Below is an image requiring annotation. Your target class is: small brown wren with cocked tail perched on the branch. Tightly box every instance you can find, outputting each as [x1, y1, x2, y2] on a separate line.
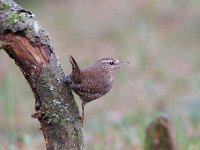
[64, 56, 129, 123]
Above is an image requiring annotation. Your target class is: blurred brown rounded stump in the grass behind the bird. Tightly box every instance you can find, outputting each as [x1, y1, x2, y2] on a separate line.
[145, 116, 177, 150]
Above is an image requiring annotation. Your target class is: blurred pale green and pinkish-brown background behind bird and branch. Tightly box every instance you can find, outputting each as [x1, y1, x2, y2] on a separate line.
[0, 0, 200, 150]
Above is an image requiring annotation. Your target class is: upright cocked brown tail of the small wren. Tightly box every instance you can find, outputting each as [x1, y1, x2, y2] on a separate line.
[69, 55, 82, 84]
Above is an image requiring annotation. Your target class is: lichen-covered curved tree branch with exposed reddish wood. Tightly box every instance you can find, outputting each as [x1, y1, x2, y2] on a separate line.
[0, 0, 83, 150]
